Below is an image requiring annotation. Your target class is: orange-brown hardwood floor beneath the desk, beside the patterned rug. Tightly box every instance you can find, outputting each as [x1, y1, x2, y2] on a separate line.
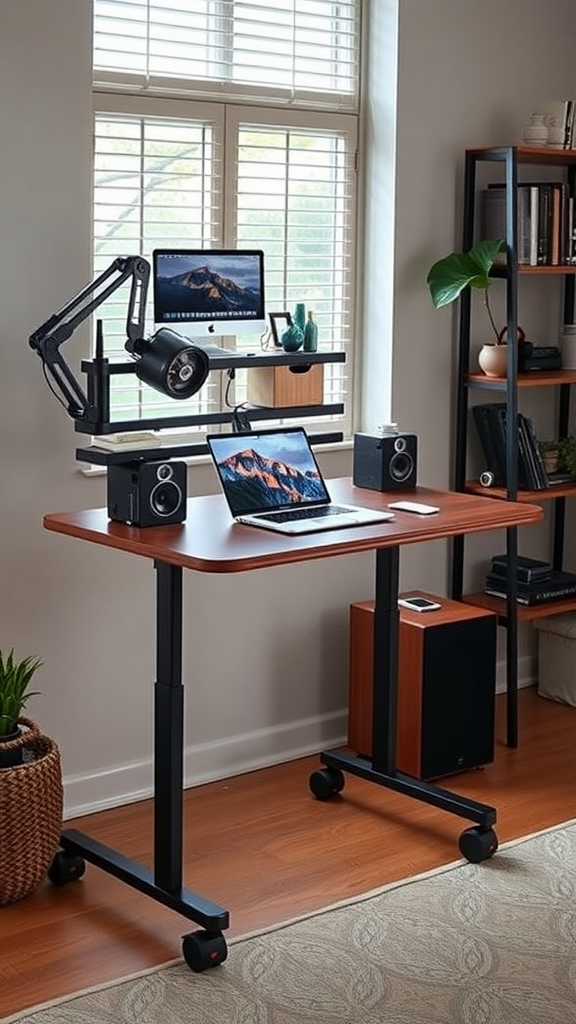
[0, 689, 576, 1019]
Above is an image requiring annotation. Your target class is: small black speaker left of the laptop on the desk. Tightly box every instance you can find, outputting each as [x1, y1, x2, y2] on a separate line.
[108, 462, 187, 526]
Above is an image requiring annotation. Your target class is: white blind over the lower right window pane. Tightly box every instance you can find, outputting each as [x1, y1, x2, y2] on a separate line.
[228, 111, 356, 415]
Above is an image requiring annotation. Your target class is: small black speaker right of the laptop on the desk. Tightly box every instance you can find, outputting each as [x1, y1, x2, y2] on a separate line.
[353, 433, 418, 490]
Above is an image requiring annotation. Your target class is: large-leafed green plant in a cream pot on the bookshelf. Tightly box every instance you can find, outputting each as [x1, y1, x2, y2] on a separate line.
[426, 239, 510, 377]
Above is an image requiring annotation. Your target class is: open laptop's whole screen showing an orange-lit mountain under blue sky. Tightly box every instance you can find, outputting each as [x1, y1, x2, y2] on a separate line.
[206, 427, 330, 516]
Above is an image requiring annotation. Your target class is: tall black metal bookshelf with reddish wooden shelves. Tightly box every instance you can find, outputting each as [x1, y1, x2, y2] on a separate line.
[451, 145, 576, 746]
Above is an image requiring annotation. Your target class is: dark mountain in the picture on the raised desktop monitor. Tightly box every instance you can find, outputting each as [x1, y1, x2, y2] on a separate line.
[158, 266, 259, 317]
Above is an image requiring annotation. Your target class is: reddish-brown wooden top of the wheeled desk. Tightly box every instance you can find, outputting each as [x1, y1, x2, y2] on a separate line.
[43, 477, 543, 572]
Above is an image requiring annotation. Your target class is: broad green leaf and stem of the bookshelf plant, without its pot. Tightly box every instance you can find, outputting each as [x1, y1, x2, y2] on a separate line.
[426, 239, 506, 345]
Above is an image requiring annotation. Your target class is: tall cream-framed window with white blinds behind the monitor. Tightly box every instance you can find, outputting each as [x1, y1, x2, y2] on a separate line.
[94, 0, 360, 434]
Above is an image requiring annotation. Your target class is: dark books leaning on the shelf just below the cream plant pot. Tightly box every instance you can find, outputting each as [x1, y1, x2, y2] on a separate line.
[472, 401, 550, 490]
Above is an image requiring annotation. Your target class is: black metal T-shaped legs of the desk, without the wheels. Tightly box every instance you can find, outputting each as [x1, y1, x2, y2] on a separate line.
[60, 547, 496, 950]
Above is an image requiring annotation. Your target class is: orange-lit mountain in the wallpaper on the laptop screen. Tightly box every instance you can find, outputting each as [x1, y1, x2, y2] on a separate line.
[218, 449, 326, 515]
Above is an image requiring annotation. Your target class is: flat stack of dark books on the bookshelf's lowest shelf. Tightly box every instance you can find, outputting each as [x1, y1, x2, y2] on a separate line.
[484, 555, 576, 605]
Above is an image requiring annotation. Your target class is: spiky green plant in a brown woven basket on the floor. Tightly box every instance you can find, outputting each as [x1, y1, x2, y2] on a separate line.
[0, 650, 63, 905]
